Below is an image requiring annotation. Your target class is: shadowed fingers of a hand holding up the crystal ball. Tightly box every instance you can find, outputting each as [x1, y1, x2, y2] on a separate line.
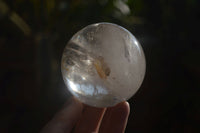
[41, 98, 130, 133]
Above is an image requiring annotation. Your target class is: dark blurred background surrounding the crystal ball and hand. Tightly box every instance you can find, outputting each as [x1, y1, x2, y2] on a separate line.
[0, 0, 200, 133]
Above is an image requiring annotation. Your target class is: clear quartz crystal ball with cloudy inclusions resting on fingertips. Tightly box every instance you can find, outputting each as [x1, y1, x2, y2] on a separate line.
[61, 23, 146, 107]
